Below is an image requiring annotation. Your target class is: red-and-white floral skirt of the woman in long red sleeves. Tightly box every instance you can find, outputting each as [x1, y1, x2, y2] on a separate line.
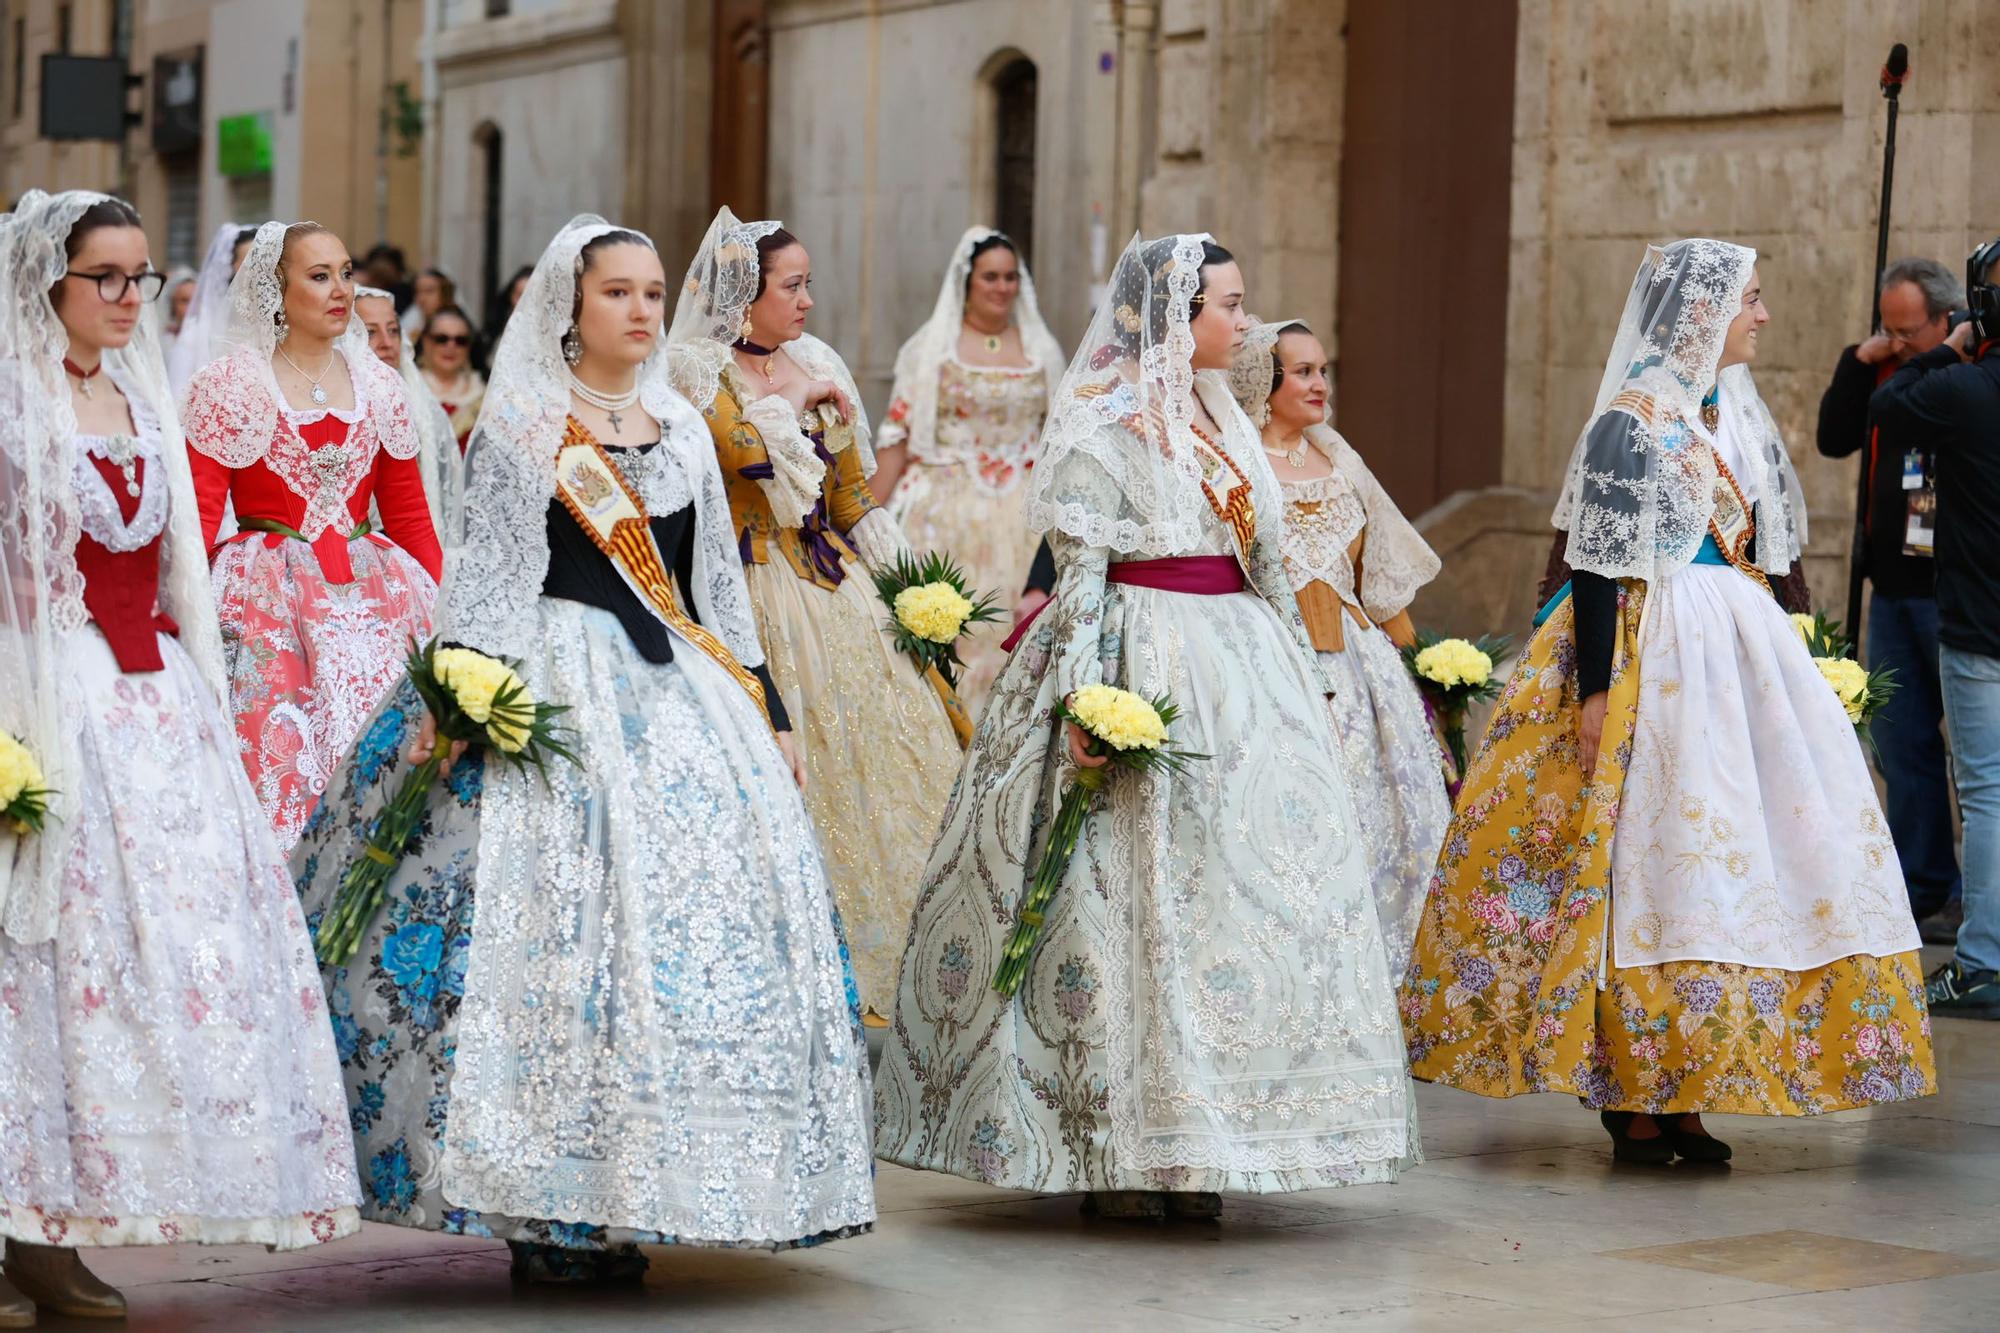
[214, 532, 438, 853]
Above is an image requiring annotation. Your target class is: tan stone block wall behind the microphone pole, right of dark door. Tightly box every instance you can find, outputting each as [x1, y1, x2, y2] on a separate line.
[1504, 0, 2000, 614]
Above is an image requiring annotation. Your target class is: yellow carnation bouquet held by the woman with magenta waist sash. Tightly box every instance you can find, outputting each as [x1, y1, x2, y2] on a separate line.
[994, 685, 1208, 995]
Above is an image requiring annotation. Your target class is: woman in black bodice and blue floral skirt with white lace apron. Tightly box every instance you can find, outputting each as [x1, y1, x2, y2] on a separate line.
[292, 216, 874, 1281]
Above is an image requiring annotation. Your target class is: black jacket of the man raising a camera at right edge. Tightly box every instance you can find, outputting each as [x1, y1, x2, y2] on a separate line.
[1870, 342, 2000, 656]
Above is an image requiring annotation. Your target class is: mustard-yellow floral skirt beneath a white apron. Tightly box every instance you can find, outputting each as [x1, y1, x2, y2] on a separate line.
[1402, 584, 1936, 1115]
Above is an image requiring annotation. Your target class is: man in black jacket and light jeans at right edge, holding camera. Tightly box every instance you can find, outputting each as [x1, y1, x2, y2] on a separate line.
[1870, 240, 2000, 1019]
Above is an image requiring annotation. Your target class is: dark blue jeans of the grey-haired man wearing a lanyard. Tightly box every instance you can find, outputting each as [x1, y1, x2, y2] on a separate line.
[1868, 592, 1960, 921]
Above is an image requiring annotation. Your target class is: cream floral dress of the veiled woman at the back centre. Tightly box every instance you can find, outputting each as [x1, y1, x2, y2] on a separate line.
[878, 356, 1048, 704]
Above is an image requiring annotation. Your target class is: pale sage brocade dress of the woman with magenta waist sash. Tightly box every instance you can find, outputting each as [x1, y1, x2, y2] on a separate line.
[876, 420, 1416, 1193]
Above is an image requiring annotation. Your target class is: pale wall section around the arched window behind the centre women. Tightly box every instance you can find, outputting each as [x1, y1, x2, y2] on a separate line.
[768, 0, 1122, 410]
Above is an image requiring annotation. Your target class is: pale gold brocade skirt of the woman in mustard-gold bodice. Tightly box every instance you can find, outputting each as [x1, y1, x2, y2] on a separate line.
[744, 560, 958, 1015]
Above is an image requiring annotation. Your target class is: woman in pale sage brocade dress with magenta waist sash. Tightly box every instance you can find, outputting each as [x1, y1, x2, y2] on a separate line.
[876, 236, 1416, 1217]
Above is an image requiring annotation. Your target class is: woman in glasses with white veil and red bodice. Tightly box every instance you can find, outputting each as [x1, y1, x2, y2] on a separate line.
[0, 190, 358, 1327]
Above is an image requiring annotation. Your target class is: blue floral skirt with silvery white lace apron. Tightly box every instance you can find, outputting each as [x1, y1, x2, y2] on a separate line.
[292, 598, 874, 1248]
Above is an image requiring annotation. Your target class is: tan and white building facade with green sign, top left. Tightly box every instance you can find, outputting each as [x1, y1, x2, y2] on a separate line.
[0, 0, 426, 264]
